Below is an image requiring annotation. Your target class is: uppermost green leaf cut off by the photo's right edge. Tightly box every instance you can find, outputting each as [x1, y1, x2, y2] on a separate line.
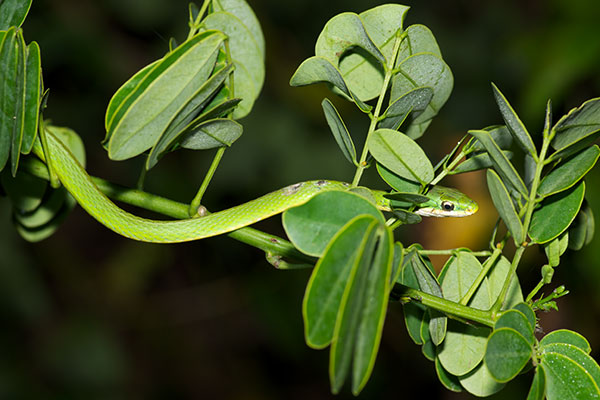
[552, 98, 600, 151]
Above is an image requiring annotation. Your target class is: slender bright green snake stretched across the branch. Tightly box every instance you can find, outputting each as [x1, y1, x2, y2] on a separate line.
[34, 131, 477, 243]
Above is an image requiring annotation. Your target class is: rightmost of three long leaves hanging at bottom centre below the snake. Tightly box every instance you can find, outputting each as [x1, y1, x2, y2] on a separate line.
[352, 225, 393, 395]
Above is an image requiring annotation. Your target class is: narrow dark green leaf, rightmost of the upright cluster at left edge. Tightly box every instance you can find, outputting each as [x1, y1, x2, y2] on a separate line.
[21, 42, 42, 154]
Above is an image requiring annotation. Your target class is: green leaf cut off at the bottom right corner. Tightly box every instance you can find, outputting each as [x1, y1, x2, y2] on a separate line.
[540, 352, 600, 400]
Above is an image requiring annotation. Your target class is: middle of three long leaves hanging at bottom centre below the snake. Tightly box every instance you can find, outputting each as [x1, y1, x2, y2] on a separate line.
[324, 216, 379, 394]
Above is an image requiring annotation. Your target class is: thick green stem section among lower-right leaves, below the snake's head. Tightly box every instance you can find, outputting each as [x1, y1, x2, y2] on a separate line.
[394, 283, 494, 328]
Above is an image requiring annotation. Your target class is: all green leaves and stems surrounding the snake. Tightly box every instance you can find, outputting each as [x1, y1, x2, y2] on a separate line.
[0, 0, 600, 399]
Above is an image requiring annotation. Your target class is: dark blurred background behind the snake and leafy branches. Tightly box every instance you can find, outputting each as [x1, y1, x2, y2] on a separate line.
[0, 0, 600, 400]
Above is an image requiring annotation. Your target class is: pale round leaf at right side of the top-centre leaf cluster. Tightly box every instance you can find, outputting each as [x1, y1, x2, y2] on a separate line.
[390, 53, 454, 130]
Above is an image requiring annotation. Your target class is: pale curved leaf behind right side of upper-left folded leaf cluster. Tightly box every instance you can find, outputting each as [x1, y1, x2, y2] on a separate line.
[202, 11, 265, 119]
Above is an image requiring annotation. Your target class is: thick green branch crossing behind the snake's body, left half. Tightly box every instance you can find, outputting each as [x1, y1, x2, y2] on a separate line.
[20, 157, 316, 264]
